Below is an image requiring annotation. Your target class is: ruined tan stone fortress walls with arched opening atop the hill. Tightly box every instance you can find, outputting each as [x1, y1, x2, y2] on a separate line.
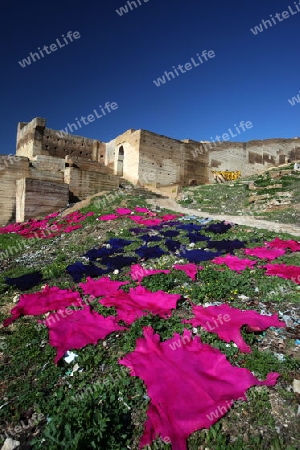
[0, 118, 300, 225]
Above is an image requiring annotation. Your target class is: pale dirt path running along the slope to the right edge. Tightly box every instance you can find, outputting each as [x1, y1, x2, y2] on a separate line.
[147, 198, 300, 236]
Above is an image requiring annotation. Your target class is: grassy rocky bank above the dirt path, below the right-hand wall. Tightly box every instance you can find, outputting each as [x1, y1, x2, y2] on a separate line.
[179, 166, 300, 225]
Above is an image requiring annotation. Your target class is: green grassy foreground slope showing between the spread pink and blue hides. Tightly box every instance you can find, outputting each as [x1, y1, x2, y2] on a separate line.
[0, 191, 300, 450]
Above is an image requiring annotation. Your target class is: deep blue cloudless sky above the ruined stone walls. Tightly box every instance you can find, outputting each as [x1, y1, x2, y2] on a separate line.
[0, 0, 300, 154]
